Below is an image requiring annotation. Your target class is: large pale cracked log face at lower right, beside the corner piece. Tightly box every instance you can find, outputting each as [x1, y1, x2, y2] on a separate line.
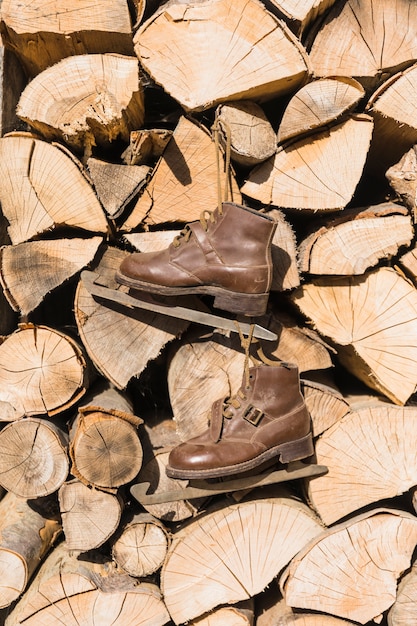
[280, 509, 417, 624]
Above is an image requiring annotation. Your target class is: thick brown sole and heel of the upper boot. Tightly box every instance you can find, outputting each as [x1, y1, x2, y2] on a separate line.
[115, 272, 269, 317]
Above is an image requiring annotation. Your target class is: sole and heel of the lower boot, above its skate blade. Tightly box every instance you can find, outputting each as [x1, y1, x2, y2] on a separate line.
[165, 432, 314, 480]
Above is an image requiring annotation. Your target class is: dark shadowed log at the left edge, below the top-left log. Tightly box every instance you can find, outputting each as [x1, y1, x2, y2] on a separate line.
[0, 35, 26, 137]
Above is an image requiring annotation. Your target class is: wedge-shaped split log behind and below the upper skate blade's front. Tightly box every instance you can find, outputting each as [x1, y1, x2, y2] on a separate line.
[74, 248, 188, 389]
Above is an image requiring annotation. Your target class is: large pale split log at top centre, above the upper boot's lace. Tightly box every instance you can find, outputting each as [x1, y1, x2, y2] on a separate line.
[133, 0, 308, 111]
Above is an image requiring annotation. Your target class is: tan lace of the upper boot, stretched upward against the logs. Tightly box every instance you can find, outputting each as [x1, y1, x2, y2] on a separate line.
[172, 110, 232, 248]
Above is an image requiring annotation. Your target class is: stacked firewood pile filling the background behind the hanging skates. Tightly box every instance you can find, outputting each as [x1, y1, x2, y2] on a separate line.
[0, 0, 417, 626]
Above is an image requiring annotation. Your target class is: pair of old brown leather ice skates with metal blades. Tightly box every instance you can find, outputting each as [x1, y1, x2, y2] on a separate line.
[84, 202, 325, 501]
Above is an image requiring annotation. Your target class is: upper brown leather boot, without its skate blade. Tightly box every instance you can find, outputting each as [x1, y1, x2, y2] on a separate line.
[116, 202, 276, 316]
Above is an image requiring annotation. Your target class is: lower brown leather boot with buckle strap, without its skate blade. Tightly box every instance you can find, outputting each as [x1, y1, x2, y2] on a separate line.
[166, 363, 314, 479]
